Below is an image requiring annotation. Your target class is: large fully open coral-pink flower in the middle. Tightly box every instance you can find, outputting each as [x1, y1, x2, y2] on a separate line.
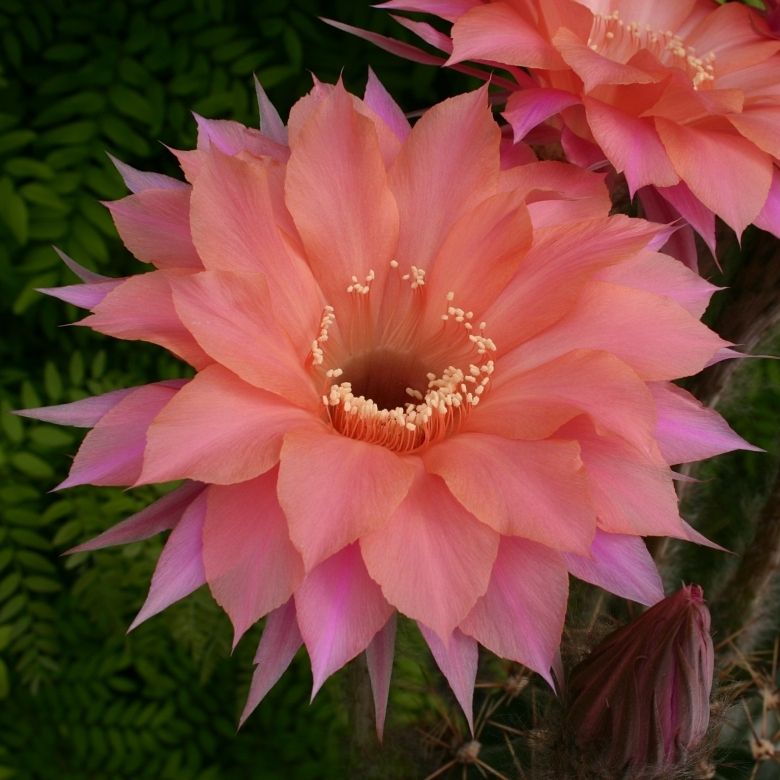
[26, 75, 749, 728]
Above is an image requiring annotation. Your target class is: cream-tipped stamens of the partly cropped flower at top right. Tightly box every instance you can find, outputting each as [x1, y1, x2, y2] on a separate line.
[588, 11, 715, 89]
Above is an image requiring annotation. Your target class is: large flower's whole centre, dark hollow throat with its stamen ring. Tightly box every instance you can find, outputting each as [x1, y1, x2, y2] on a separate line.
[311, 261, 496, 452]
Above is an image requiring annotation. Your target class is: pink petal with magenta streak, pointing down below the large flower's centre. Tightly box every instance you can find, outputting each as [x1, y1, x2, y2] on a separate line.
[295, 544, 393, 699]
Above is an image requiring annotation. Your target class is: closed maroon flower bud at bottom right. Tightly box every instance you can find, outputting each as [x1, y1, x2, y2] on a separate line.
[568, 585, 714, 777]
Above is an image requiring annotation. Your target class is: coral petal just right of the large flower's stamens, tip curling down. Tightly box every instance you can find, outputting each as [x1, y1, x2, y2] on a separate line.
[470, 349, 655, 447]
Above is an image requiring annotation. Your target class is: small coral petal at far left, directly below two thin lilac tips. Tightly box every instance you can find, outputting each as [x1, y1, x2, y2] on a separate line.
[77, 271, 212, 369]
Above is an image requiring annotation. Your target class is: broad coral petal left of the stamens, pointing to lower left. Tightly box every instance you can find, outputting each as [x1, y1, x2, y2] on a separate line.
[137, 365, 321, 485]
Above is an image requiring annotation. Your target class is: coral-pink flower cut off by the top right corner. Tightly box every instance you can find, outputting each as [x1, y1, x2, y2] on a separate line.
[362, 0, 780, 264]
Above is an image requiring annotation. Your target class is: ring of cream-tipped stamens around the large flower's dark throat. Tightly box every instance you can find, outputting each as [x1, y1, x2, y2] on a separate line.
[311, 260, 496, 452]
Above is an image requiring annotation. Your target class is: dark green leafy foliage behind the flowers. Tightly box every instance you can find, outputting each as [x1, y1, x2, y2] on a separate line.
[0, 0, 780, 780]
